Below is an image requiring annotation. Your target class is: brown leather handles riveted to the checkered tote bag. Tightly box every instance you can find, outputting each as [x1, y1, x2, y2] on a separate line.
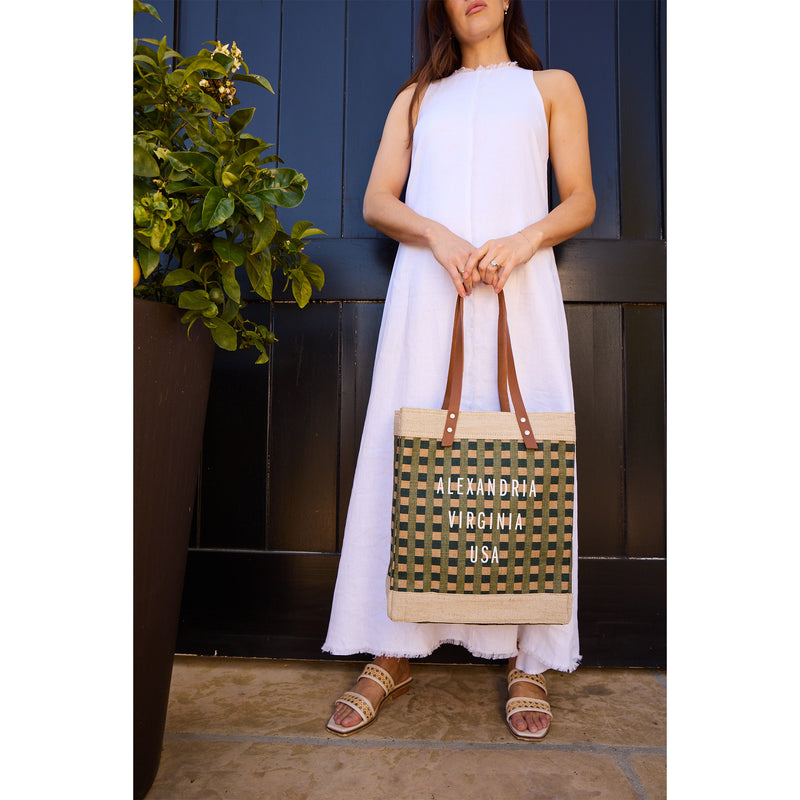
[442, 291, 539, 450]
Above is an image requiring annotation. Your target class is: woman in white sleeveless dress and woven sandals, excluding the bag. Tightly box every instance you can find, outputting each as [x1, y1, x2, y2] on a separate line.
[323, 0, 595, 739]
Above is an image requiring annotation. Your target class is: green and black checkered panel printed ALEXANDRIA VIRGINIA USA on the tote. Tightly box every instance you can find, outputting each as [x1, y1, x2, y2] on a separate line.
[389, 436, 575, 595]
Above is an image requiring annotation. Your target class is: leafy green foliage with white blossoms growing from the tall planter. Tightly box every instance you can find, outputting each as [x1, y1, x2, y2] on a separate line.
[133, 0, 325, 354]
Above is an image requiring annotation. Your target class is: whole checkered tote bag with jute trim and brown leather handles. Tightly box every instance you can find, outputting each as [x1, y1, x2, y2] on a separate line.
[386, 292, 575, 624]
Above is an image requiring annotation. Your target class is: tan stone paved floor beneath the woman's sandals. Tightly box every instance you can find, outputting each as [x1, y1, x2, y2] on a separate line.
[147, 656, 666, 800]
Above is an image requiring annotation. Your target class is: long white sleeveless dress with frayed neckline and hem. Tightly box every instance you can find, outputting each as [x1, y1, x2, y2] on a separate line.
[322, 63, 580, 672]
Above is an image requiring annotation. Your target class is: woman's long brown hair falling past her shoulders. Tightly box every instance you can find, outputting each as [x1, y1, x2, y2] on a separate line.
[398, 0, 542, 145]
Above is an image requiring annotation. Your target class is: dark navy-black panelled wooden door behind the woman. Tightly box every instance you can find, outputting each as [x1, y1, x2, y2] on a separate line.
[137, 0, 666, 666]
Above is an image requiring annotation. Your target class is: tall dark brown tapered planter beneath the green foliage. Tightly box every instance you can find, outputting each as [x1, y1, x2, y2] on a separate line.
[133, 298, 214, 800]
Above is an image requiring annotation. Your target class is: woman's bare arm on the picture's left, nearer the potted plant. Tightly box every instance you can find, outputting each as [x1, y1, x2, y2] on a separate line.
[364, 86, 475, 297]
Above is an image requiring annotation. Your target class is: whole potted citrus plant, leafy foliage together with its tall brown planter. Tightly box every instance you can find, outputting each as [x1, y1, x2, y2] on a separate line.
[133, 0, 324, 798]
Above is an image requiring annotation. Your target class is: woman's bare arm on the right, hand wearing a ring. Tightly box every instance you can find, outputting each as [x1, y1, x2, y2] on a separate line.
[465, 70, 595, 292]
